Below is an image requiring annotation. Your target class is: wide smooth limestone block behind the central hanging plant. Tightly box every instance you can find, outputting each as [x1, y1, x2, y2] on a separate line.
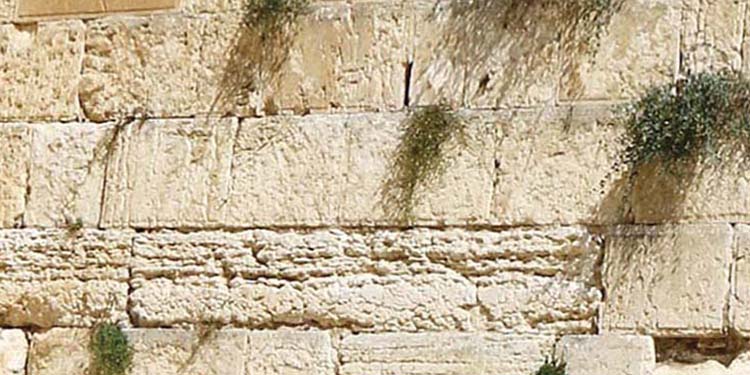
[226, 114, 492, 227]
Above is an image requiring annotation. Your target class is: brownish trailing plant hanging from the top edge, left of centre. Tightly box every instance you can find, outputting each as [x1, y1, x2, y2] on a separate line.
[210, 0, 310, 114]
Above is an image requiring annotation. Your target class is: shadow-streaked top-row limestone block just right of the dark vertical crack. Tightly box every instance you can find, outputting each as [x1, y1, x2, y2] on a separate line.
[407, 0, 560, 108]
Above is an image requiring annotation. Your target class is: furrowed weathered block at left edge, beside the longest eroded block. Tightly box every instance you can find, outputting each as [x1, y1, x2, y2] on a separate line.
[0, 230, 130, 327]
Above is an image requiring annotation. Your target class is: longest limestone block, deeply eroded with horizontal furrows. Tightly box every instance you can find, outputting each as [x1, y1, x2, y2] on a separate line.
[131, 228, 601, 332]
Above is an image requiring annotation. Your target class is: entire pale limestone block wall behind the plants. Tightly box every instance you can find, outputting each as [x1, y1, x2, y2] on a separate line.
[0, 0, 750, 375]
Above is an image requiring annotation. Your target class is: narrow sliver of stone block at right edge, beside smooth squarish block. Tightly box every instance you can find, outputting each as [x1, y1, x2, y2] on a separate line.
[729, 224, 750, 336]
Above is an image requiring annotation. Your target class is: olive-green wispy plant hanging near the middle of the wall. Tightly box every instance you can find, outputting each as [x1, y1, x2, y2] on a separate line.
[382, 105, 467, 222]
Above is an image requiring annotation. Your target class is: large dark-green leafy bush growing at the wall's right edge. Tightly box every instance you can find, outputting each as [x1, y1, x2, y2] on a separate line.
[619, 71, 750, 173]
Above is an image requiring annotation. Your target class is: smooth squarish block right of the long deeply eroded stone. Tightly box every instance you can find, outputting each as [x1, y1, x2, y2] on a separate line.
[602, 224, 733, 337]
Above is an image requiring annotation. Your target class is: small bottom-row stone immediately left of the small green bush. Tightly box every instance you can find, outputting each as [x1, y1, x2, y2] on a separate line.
[27, 328, 91, 375]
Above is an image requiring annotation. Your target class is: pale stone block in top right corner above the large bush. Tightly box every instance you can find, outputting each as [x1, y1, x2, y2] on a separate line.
[680, 0, 747, 74]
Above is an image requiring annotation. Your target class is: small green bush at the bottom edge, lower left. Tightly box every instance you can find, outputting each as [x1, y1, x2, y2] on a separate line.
[90, 323, 133, 375]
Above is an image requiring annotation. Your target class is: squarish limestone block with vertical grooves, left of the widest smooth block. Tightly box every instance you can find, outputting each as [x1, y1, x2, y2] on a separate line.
[102, 119, 237, 228]
